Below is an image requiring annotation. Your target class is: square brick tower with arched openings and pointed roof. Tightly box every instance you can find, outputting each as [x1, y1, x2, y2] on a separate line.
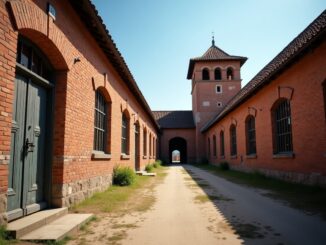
[187, 37, 247, 161]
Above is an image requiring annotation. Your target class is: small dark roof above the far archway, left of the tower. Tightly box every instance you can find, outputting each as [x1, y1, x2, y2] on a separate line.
[153, 111, 195, 128]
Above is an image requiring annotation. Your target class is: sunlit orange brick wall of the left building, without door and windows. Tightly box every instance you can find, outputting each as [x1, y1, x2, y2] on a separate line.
[0, 0, 157, 223]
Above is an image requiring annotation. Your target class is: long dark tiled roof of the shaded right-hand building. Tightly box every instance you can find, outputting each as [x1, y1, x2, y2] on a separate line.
[201, 10, 326, 132]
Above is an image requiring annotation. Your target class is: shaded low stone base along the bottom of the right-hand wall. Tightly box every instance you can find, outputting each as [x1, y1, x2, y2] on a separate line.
[231, 166, 326, 187]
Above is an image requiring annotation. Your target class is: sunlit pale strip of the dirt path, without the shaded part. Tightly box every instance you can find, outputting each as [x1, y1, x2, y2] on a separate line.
[122, 166, 241, 245]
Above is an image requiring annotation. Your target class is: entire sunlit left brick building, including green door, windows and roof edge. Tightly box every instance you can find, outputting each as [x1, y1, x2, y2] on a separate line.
[0, 0, 158, 223]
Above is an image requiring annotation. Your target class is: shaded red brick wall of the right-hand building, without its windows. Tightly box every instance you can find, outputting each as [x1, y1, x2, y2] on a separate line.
[205, 41, 326, 185]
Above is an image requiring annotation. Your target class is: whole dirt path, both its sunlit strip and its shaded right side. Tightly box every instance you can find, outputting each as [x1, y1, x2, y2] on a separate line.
[68, 165, 326, 245]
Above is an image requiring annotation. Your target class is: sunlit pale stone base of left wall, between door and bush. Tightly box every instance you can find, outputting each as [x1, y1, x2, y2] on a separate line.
[52, 175, 112, 207]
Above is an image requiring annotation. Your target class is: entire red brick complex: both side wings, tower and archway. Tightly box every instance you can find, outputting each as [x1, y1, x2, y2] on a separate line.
[0, 0, 326, 227]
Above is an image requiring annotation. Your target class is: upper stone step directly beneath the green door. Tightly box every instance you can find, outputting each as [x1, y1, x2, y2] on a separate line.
[7, 208, 68, 239]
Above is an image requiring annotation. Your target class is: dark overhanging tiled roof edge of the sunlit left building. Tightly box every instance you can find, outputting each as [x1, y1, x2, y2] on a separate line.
[69, 0, 159, 129]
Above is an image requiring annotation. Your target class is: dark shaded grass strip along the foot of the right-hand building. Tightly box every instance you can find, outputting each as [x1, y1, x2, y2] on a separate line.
[194, 164, 326, 219]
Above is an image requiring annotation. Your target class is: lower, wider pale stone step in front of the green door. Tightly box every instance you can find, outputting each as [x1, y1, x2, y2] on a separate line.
[20, 214, 93, 241]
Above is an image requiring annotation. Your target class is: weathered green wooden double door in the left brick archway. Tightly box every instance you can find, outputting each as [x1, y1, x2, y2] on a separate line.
[8, 75, 47, 220]
